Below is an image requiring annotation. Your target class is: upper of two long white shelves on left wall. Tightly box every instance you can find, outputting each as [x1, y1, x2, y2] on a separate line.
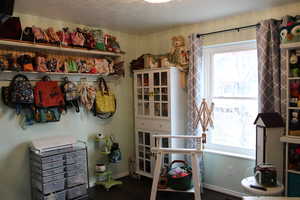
[0, 40, 125, 57]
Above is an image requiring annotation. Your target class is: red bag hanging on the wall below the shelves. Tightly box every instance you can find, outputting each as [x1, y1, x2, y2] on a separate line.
[34, 76, 65, 108]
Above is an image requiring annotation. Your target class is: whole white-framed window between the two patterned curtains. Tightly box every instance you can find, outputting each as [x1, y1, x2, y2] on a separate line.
[203, 41, 258, 157]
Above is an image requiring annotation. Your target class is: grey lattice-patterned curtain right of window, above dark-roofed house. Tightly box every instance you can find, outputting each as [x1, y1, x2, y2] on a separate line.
[256, 16, 290, 118]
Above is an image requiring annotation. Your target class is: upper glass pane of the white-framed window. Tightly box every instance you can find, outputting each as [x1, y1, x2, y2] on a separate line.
[212, 49, 258, 97]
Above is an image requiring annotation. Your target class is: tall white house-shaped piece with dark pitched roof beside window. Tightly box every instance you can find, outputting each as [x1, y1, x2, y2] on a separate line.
[254, 113, 284, 181]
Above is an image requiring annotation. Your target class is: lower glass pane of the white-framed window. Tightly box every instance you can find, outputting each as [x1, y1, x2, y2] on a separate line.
[208, 99, 258, 149]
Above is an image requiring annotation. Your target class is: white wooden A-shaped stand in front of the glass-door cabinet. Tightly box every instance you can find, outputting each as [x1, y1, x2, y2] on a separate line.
[150, 135, 203, 200]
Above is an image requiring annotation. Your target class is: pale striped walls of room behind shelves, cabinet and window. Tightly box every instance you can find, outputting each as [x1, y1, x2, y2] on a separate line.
[0, 3, 300, 200]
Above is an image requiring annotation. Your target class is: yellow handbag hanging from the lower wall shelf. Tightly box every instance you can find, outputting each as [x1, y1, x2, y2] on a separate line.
[95, 78, 116, 114]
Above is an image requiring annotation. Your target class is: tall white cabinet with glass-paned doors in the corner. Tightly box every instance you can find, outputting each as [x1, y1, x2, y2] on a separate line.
[134, 67, 186, 177]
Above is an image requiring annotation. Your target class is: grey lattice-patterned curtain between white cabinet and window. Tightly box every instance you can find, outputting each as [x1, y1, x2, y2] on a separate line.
[187, 34, 204, 192]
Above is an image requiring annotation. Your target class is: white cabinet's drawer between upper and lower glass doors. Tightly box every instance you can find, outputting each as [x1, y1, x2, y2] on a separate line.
[136, 120, 171, 131]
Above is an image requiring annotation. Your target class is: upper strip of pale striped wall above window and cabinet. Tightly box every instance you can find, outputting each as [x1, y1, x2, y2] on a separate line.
[138, 2, 300, 54]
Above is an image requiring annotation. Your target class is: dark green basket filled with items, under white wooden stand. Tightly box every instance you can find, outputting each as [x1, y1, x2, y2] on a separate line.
[167, 160, 193, 190]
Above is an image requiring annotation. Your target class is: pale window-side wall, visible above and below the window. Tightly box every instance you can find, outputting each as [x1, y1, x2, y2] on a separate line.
[138, 2, 300, 195]
